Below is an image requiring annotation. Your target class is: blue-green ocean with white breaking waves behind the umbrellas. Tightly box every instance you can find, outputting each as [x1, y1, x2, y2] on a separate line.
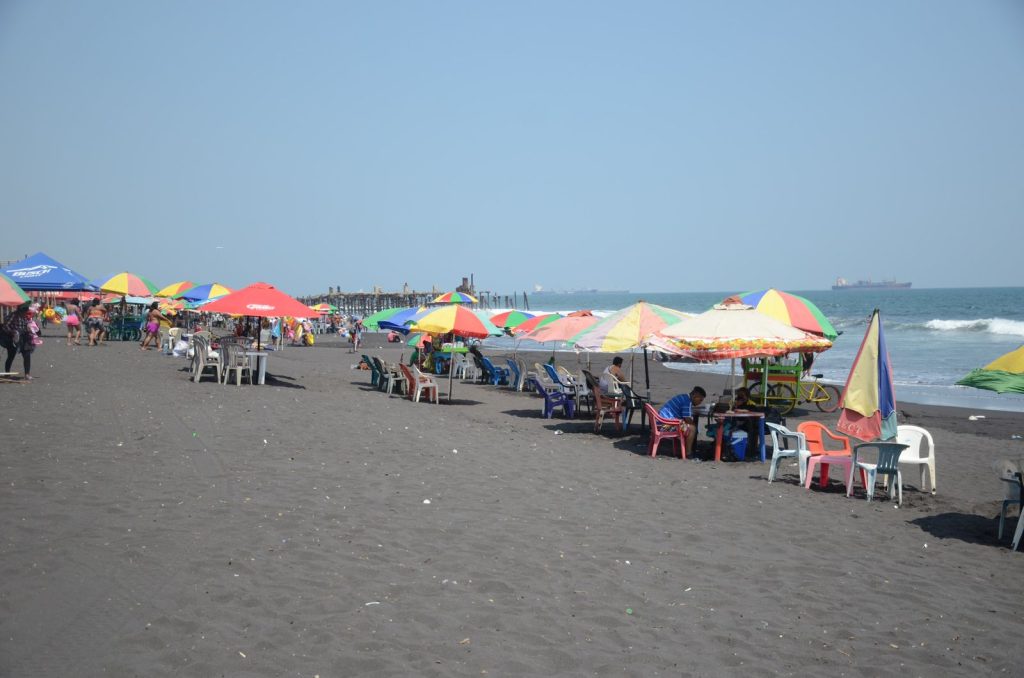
[485, 288, 1024, 412]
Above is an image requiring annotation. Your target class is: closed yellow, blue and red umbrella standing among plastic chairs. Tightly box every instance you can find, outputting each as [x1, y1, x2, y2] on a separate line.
[836, 308, 897, 442]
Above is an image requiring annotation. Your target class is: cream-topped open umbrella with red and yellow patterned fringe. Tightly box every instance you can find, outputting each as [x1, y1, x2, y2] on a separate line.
[657, 297, 831, 401]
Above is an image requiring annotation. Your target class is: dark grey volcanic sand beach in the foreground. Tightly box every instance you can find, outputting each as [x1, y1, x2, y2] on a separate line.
[0, 330, 1024, 678]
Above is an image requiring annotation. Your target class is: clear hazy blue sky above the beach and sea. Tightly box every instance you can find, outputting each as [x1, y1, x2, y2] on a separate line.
[0, 0, 1024, 295]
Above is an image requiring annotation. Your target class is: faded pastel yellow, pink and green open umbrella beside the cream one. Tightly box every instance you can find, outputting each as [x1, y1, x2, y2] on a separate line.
[569, 300, 690, 392]
